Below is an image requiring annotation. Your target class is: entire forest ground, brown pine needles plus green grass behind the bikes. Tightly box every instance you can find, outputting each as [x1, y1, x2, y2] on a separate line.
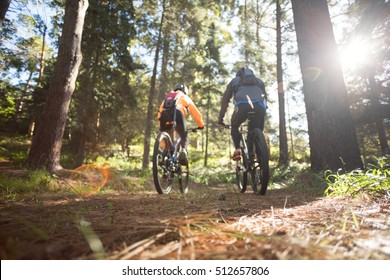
[0, 137, 390, 260]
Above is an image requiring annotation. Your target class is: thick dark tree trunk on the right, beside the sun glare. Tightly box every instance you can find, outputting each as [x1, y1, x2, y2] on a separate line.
[292, 0, 362, 170]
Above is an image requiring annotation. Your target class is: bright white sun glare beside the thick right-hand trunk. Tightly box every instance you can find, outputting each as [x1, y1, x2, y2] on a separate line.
[340, 41, 368, 69]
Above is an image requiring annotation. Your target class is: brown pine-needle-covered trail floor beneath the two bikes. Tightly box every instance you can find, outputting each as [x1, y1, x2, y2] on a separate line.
[0, 162, 390, 260]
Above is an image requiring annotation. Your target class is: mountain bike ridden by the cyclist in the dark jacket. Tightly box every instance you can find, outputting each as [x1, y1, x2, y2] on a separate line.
[225, 103, 270, 195]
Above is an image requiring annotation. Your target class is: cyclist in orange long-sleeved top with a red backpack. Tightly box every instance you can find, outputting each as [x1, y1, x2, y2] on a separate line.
[157, 84, 204, 165]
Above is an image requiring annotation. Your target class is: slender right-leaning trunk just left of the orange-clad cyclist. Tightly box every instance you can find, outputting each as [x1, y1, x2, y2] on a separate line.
[142, 1, 165, 169]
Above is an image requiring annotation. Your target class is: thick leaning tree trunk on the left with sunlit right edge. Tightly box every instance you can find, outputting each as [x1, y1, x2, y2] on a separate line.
[27, 0, 88, 172]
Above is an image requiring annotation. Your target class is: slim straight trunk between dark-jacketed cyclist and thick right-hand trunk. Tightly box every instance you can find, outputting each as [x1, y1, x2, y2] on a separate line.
[276, 0, 288, 166]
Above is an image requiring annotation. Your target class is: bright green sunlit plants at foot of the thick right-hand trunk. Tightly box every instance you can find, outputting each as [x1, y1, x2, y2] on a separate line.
[325, 157, 390, 197]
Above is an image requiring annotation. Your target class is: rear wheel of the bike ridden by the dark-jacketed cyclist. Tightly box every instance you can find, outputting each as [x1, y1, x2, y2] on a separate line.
[251, 128, 269, 195]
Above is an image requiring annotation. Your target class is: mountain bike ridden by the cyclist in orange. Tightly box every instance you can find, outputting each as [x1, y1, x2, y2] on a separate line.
[153, 126, 199, 194]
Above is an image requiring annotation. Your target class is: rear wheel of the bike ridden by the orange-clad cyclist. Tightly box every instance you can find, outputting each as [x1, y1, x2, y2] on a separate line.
[153, 132, 173, 194]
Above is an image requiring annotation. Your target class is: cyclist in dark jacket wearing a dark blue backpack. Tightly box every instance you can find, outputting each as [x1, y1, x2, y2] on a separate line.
[218, 68, 267, 161]
